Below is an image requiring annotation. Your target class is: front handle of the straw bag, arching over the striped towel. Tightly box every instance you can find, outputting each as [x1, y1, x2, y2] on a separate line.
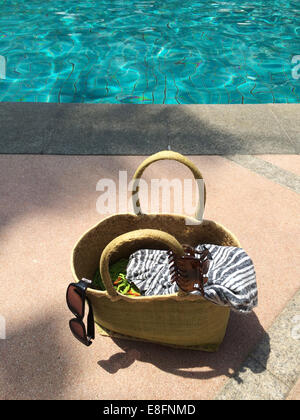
[99, 229, 184, 296]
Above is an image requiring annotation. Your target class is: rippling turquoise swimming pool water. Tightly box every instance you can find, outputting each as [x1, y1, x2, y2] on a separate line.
[0, 0, 300, 104]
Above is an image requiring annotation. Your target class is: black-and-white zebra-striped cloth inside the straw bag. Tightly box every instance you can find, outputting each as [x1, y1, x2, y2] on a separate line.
[126, 244, 257, 312]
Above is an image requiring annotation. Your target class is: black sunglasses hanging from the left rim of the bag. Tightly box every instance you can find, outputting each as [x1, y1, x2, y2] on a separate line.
[66, 278, 95, 346]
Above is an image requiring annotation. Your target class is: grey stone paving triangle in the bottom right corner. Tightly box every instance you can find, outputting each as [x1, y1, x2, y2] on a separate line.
[216, 291, 300, 400]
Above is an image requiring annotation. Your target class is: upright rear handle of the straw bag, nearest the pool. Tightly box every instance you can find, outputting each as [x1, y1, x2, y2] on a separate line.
[132, 150, 206, 221]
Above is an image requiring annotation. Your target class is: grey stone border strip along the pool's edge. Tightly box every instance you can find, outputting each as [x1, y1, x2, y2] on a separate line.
[0, 102, 300, 155]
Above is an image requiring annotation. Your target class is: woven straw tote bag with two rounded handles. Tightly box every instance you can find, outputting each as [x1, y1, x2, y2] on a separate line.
[72, 151, 240, 351]
